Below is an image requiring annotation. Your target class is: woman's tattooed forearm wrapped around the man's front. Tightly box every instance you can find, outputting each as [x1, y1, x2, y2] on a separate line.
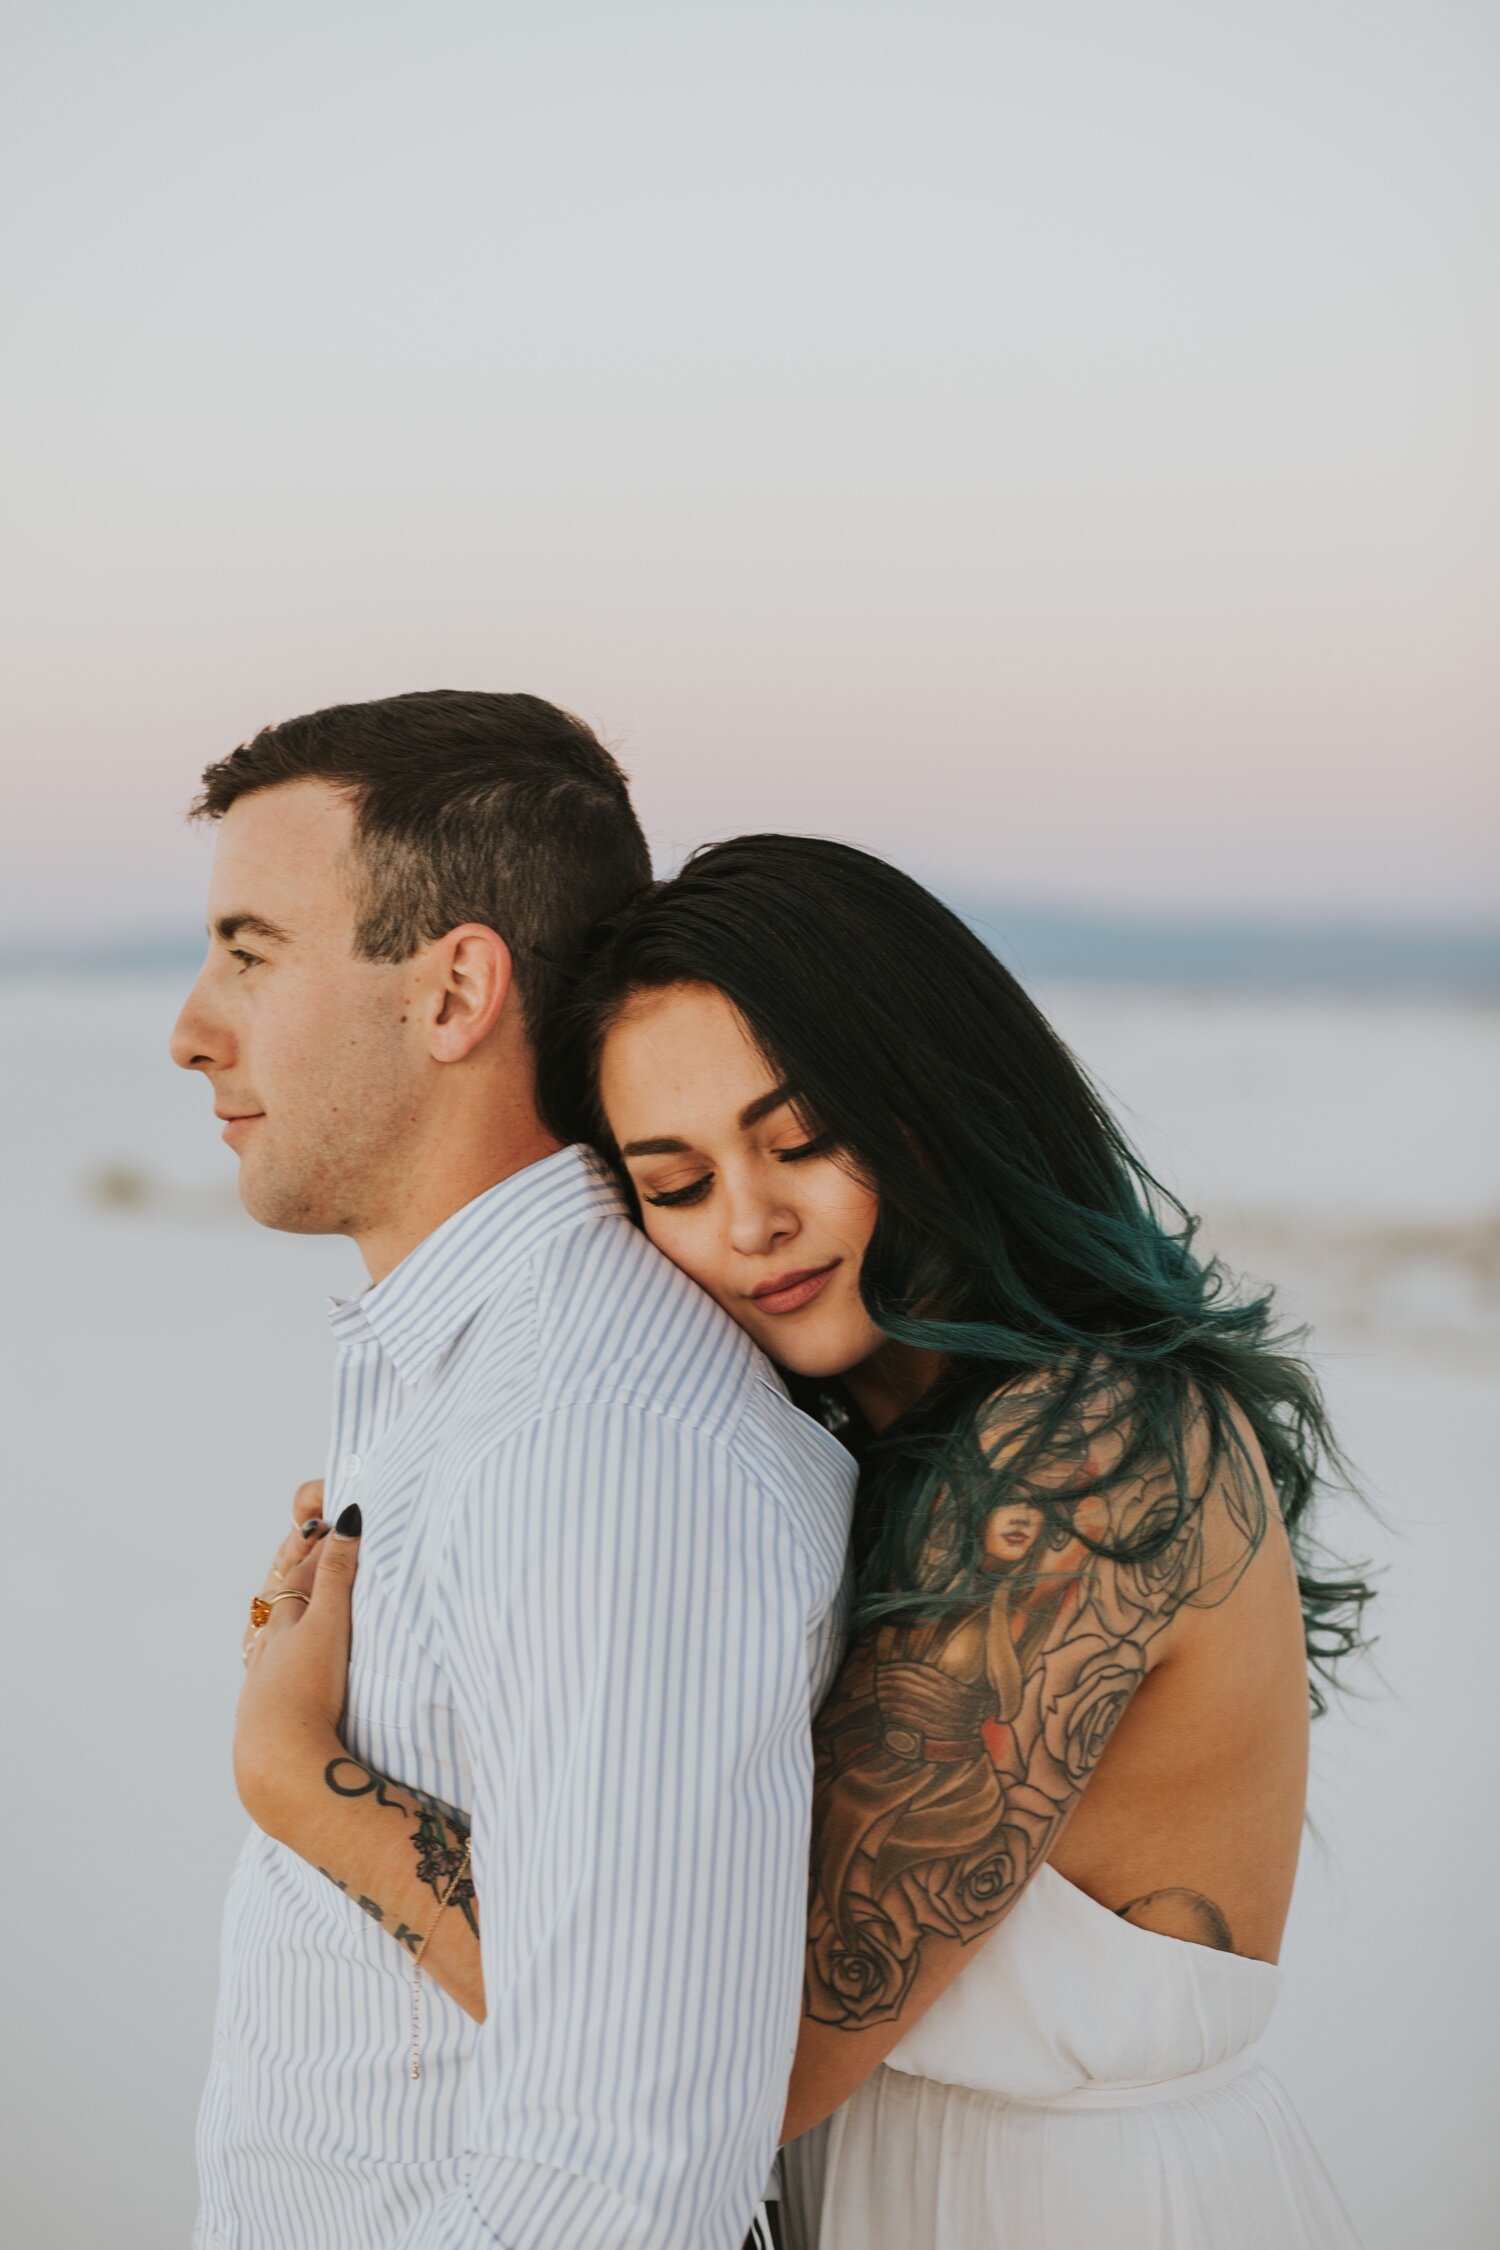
[250, 1735, 484, 2023]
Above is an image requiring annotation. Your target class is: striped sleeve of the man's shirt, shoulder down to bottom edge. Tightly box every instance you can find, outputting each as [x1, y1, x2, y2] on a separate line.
[405, 1404, 816, 2250]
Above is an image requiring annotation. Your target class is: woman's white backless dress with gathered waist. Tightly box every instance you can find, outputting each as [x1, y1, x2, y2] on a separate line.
[783, 1868, 1358, 2250]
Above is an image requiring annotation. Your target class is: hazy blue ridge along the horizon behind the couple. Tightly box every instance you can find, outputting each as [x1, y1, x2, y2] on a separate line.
[0, 898, 1500, 1001]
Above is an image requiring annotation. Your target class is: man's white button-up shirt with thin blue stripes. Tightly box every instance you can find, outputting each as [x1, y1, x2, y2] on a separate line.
[193, 1150, 852, 2250]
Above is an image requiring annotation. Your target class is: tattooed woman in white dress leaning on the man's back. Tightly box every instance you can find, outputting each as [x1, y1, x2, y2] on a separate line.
[246, 837, 1365, 2250]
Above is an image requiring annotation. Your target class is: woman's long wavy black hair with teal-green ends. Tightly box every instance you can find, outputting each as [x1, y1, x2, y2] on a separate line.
[540, 835, 1370, 1710]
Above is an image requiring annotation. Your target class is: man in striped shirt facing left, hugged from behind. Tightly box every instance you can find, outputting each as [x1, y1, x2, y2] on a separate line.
[173, 693, 852, 2250]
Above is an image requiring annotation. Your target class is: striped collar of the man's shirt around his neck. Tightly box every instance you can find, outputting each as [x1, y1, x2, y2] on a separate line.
[331, 1148, 625, 1384]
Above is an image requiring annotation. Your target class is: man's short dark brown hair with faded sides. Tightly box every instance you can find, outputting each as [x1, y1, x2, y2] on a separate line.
[191, 689, 650, 1042]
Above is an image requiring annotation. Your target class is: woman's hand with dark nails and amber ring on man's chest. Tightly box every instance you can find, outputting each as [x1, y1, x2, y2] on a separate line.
[234, 1483, 360, 1836]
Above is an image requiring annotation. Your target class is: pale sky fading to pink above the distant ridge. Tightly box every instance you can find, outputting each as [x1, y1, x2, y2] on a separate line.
[0, 0, 1500, 938]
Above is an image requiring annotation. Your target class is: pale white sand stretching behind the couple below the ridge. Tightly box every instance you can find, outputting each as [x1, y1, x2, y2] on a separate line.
[0, 981, 1500, 2250]
